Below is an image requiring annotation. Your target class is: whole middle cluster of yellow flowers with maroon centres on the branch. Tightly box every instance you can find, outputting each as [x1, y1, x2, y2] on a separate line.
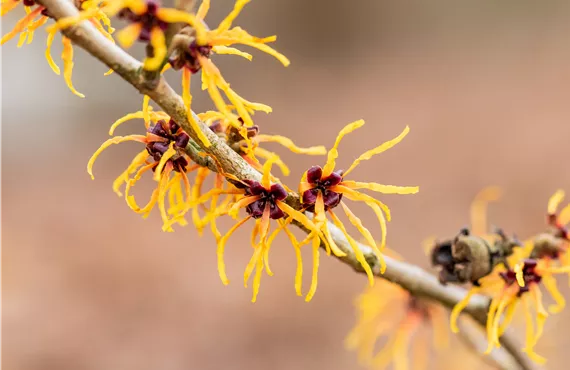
[88, 97, 417, 301]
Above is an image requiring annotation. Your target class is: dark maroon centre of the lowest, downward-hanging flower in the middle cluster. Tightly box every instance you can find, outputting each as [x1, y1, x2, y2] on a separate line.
[245, 180, 287, 220]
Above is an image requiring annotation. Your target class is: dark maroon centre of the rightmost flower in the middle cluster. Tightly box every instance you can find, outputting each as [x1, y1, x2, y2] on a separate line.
[303, 166, 342, 212]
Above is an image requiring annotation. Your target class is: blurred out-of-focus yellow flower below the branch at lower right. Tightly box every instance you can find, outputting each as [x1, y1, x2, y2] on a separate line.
[345, 280, 449, 370]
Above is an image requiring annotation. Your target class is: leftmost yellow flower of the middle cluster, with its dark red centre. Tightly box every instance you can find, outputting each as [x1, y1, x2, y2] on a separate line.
[87, 110, 196, 231]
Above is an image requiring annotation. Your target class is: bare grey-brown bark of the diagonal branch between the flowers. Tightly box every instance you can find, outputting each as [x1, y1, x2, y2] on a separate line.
[37, 0, 533, 370]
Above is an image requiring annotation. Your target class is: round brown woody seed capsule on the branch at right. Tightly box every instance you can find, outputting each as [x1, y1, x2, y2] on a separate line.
[431, 228, 521, 285]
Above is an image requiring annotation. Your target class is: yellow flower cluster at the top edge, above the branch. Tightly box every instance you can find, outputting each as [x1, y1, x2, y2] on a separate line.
[47, 0, 289, 147]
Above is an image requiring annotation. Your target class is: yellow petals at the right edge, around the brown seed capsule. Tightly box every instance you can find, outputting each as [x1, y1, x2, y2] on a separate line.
[450, 187, 570, 364]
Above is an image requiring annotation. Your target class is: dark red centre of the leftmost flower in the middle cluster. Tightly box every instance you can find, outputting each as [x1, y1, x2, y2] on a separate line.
[146, 120, 190, 172]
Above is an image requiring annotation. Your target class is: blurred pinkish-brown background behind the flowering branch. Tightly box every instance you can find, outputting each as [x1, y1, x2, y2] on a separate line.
[0, 0, 570, 370]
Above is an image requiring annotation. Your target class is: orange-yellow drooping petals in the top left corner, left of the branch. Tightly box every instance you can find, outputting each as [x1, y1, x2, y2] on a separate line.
[0, 0, 114, 98]
